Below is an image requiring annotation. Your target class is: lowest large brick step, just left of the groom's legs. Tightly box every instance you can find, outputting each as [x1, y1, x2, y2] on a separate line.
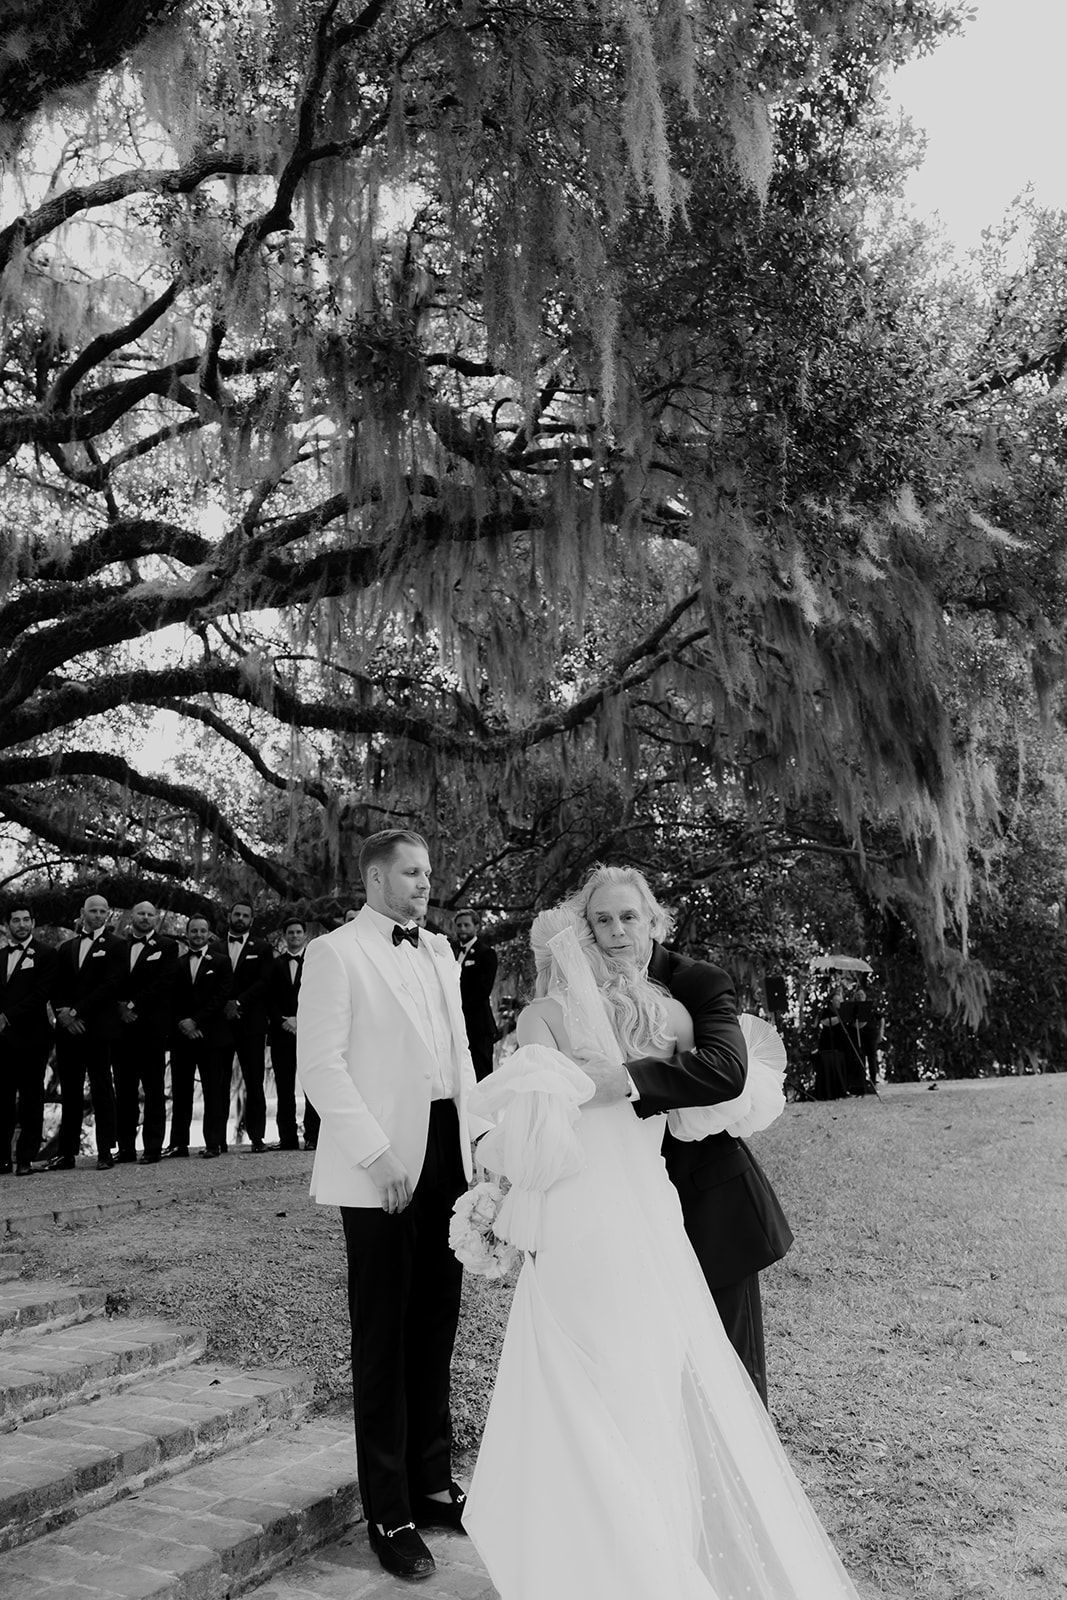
[0, 1419, 362, 1600]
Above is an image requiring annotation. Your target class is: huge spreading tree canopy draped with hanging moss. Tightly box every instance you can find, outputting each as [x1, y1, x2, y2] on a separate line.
[0, 0, 1067, 1011]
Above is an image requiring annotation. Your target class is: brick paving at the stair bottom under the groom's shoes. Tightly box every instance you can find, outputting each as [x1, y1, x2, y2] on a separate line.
[248, 1523, 495, 1600]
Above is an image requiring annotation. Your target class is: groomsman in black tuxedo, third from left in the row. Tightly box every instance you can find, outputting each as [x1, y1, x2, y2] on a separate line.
[112, 901, 178, 1165]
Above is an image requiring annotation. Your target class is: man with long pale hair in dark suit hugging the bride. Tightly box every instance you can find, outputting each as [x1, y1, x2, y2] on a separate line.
[568, 867, 793, 1403]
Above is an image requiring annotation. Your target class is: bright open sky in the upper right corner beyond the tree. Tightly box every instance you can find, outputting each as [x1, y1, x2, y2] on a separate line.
[888, 0, 1067, 250]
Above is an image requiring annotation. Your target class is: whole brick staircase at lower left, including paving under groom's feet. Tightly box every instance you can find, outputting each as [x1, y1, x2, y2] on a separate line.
[0, 1246, 494, 1600]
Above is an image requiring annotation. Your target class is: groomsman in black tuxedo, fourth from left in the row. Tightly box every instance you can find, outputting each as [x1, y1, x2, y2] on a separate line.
[163, 915, 234, 1160]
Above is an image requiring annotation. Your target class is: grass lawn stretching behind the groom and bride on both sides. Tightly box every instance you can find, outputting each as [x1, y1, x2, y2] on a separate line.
[12, 1075, 1067, 1600]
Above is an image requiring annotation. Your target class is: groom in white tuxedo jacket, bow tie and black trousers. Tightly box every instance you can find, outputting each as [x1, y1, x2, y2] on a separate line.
[296, 829, 488, 1578]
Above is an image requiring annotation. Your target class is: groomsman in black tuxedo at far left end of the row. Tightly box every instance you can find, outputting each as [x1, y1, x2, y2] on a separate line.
[0, 906, 56, 1178]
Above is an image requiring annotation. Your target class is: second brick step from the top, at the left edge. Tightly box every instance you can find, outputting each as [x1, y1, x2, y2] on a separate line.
[0, 1317, 205, 1430]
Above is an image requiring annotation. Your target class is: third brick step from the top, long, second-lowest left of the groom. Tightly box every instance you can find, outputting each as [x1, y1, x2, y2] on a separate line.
[0, 1365, 314, 1550]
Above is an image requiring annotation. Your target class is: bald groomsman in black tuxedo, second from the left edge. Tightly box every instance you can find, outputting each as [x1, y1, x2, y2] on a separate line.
[48, 894, 128, 1171]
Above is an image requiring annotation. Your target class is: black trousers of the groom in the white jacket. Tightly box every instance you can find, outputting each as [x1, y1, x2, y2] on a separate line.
[341, 1101, 467, 1528]
